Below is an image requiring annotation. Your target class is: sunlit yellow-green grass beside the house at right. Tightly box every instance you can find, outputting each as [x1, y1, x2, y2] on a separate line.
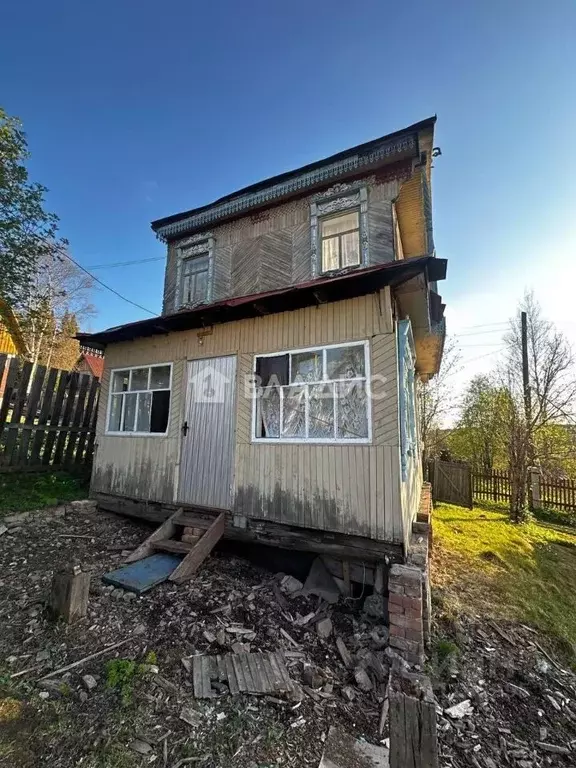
[432, 504, 576, 663]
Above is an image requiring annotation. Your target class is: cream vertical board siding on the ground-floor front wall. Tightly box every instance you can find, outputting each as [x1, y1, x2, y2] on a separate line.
[93, 290, 403, 542]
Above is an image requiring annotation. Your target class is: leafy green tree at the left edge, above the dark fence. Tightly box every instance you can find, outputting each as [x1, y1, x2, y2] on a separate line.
[0, 107, 66, 309]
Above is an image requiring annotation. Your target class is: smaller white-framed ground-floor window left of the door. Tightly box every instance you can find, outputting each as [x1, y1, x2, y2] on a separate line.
[106, 363, 172, 435]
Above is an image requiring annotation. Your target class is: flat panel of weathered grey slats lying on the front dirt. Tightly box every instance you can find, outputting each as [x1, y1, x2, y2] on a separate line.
[192, 652, 294, 699]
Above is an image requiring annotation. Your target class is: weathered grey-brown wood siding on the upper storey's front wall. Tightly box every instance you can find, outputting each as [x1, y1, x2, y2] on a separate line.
[163, 176, 400, 314]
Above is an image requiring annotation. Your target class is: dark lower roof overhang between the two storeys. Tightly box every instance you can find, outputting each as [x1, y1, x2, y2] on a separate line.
[76, 256, 447, 349]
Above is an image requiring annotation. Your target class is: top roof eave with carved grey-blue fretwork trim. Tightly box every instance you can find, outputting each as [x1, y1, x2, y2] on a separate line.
[151, 116, 436, 240]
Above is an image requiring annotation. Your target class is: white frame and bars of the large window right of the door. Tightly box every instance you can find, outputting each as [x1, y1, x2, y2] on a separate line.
[251, 341, 372, 445]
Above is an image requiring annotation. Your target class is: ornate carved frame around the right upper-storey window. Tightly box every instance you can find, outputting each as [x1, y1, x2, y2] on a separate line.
[310, 183, 369, 277]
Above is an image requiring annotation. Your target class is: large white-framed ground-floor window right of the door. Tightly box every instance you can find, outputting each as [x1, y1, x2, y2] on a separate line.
[253, 342, 370, 443]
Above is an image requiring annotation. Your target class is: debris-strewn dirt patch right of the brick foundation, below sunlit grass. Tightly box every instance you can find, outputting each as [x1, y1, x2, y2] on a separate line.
[430, 612, 576, 768]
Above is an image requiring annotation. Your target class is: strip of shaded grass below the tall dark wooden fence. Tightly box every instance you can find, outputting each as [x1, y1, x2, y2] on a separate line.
[0, 472, 89, 518]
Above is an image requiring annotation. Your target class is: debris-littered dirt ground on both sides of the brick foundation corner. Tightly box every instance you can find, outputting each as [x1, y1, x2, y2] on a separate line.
[0, 505, 576, 768]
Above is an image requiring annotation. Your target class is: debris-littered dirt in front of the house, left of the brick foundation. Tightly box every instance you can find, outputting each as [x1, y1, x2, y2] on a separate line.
[0, 505, 387, 768]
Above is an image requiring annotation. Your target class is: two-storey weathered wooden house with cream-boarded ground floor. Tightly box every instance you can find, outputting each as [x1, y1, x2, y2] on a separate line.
[79, 118, 446, 561]
